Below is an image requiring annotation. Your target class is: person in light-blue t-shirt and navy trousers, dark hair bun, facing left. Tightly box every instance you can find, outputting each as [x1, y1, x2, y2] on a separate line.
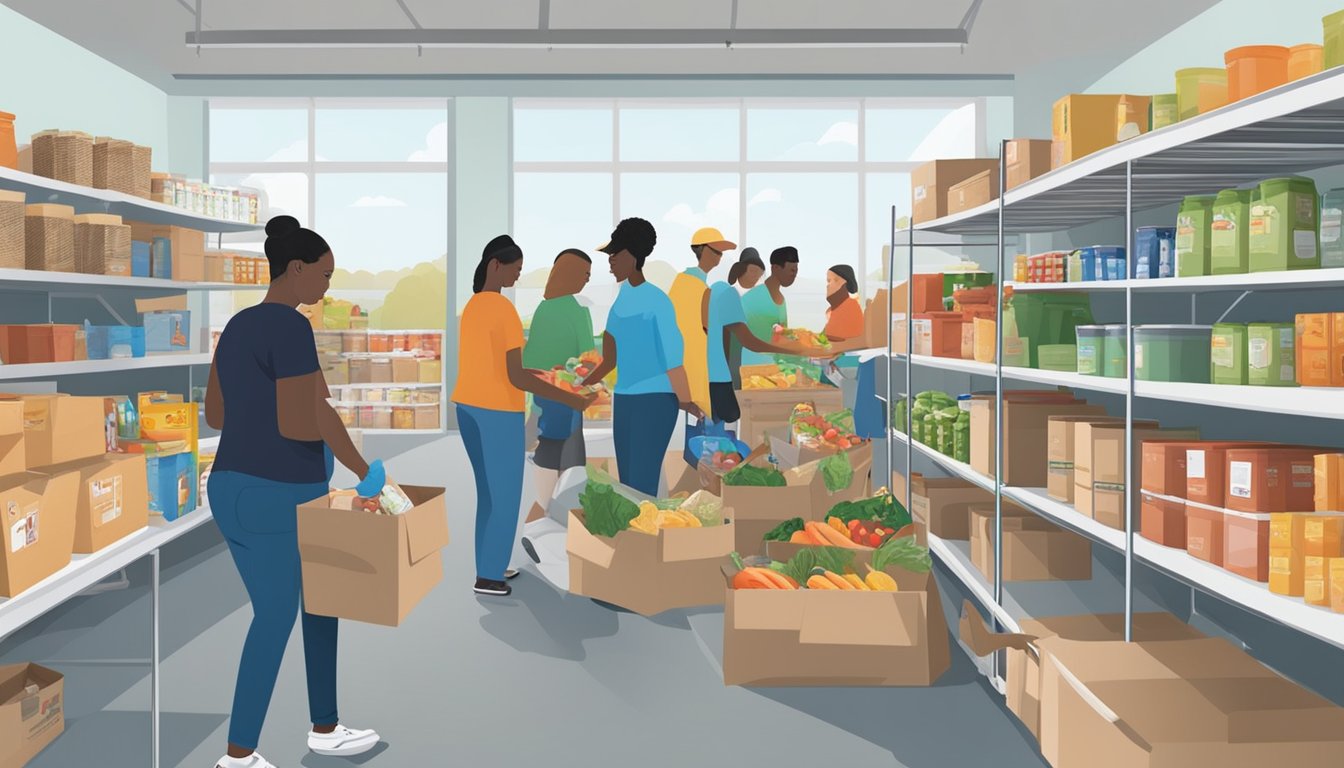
[583, 218, 704, 496]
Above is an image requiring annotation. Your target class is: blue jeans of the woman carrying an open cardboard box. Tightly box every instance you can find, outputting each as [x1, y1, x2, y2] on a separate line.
[208, 472, 339, 749]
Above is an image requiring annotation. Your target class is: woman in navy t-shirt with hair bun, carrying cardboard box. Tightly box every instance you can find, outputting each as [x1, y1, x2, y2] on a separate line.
[206, 217, 386, 768]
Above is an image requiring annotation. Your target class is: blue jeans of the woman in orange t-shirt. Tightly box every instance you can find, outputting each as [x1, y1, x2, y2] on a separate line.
[457, 404, 527, 581]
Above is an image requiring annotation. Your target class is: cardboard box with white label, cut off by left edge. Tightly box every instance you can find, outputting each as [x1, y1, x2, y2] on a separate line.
[0, 472, 79, 597]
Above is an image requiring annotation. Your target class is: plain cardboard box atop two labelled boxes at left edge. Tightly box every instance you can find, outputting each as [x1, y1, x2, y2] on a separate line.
[0, 394, 108, 467]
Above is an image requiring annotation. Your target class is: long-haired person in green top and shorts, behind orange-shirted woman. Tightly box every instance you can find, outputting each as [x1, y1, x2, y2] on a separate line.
[523, 249, 597, 523]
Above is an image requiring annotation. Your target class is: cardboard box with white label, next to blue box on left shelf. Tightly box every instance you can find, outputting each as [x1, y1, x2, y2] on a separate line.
[34, 453, 149, 554]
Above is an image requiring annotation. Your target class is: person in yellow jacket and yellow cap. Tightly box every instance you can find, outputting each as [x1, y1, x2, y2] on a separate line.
[668, 227, 738, 464]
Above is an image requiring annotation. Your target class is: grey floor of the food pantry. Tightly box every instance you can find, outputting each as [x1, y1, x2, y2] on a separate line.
[0, 438, 1044, 768]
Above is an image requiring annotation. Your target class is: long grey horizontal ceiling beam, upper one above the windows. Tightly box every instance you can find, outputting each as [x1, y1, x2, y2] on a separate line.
[185, 28, 968, 48]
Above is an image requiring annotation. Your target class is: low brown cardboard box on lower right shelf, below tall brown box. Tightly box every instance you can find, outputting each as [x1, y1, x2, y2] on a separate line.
[969, 503, 1091, 581]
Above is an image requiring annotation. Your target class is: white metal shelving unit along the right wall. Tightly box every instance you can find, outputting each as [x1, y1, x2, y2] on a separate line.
[881, 63, 1344, 685]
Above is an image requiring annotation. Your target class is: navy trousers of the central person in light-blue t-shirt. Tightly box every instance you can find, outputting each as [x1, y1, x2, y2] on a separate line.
[612, 393, 680, 496]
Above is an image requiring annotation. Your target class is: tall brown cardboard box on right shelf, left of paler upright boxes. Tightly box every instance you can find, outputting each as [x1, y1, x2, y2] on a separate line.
[970, 391, 1106, 488]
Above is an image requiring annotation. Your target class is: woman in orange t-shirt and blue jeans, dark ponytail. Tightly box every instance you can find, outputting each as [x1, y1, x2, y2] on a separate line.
[453, 234, 593, 596]
